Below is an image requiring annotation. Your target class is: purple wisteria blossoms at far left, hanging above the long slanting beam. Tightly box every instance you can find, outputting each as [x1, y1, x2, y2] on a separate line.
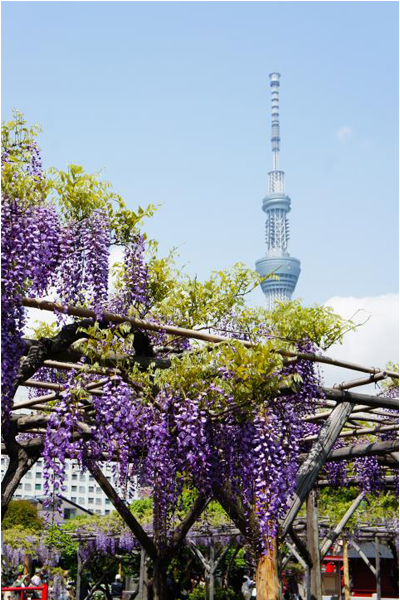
[1, 127, 147, 423]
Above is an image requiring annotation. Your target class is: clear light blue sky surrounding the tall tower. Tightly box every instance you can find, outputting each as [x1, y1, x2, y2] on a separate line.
[2, 2, 399, 304]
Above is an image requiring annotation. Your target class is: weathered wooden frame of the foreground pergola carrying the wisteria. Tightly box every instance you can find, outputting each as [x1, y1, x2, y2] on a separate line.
[2, 298, 399, 600]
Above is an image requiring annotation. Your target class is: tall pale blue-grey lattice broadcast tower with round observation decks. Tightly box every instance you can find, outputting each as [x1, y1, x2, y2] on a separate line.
[256, 73, 300, 310]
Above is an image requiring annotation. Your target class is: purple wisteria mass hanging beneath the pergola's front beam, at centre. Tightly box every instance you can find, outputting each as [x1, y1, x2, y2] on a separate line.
[40, 344, 319, 547]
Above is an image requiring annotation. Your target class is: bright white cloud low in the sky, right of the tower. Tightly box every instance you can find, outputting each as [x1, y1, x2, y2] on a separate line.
[324, 294, 399, 392]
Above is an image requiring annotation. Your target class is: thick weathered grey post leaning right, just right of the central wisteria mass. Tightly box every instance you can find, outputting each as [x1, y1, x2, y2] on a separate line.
[281, 402, 354, 540]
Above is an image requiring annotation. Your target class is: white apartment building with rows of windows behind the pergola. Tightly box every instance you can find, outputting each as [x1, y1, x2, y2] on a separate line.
[1, 456, 139, 515]
